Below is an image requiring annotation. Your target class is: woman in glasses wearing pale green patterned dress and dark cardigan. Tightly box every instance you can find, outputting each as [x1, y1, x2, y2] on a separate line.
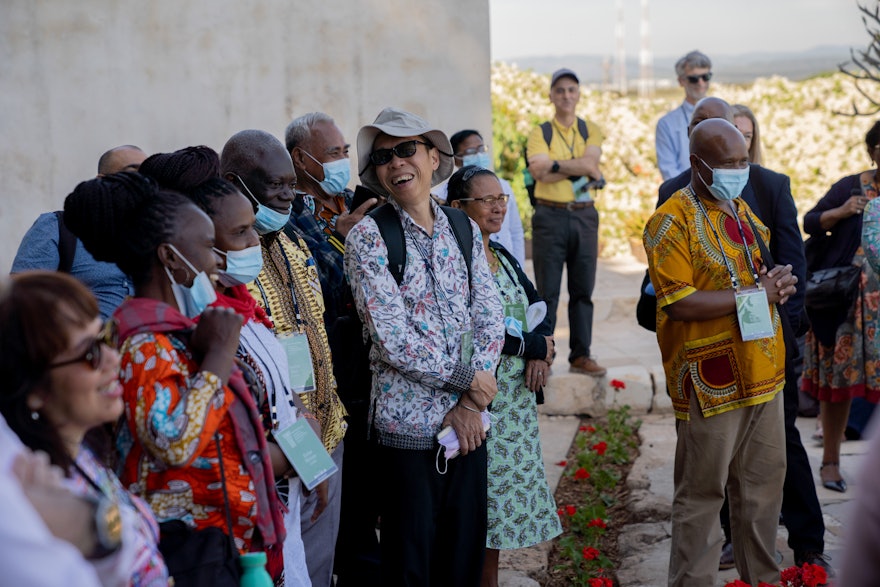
[447, 165, 562, 587]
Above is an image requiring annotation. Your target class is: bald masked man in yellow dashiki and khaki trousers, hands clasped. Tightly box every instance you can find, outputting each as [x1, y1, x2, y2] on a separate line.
[644, 119, 797, 587]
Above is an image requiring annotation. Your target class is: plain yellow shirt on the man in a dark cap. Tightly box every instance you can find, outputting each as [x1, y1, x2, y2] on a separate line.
[526, 119, 605, 202]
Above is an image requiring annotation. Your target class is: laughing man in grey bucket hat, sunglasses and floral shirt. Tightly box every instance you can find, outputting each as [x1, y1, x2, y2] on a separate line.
[345, 108, 504, 586]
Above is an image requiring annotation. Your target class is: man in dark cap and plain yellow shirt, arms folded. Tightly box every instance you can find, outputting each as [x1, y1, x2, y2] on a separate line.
[528, 69, 606, 377]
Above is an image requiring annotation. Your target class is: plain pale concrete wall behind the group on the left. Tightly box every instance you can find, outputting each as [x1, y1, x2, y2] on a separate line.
[0, 0, 491, 272]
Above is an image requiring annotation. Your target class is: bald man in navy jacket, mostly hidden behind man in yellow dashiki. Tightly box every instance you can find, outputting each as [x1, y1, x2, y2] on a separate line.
[657, 97, 830, 570]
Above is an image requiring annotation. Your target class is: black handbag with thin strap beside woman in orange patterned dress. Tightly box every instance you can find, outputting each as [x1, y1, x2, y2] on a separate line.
[159, 434, 241, 587]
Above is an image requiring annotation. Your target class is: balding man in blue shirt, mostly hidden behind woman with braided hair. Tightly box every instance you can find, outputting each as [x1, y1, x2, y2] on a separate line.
[10, 145, 147, 319]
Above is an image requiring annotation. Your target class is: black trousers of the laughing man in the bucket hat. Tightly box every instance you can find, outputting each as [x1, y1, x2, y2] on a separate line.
[376, 442, 487, 587]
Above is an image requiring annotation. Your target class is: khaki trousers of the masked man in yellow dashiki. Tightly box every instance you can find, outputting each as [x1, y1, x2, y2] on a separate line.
[669, 392, 785, 587]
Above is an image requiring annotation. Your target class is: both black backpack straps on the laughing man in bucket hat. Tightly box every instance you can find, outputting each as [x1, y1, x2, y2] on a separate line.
[367, 203, 474, 289]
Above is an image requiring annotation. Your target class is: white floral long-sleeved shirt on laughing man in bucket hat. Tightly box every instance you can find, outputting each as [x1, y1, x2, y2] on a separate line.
[345, 202, 504, 450]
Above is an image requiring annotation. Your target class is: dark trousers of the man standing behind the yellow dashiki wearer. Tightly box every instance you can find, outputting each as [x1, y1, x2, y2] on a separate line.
[721, 314, 825, 552]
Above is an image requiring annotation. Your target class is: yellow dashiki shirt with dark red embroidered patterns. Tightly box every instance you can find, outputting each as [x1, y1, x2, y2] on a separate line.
[644, 186, 785, 420]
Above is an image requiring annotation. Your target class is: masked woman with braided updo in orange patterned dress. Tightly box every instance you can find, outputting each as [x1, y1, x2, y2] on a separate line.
[64, 173, 284, 575]
